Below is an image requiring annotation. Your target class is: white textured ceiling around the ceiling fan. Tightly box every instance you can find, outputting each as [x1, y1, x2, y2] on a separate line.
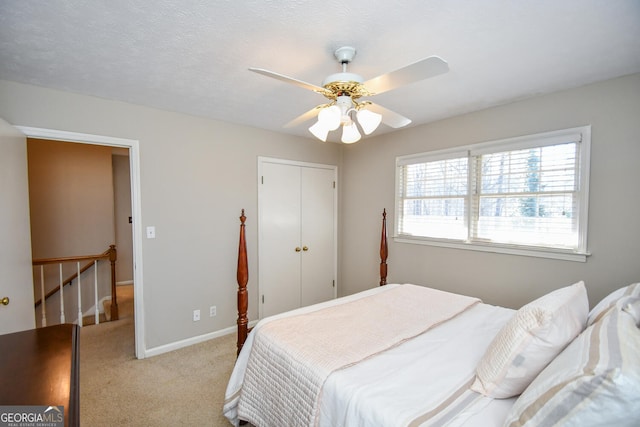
[0, 0, 640, 143]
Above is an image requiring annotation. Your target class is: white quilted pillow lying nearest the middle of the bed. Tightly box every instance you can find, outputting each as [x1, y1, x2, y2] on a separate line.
[471, 281, 589, 398]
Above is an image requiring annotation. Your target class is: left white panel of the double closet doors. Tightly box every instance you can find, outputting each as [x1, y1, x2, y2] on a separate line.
[259, 163, 302, 317]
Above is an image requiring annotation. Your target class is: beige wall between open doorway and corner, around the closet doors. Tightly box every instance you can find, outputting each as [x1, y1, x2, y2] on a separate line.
[0, 81, 341, 349]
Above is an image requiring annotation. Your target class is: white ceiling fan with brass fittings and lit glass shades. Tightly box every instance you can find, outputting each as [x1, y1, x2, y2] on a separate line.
[249, 46, 449, 144]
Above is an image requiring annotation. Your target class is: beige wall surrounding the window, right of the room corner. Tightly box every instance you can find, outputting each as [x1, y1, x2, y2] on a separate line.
[342, 74, 640, 307]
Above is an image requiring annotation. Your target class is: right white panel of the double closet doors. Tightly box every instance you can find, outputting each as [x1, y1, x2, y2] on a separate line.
[300, 167, 336, 306]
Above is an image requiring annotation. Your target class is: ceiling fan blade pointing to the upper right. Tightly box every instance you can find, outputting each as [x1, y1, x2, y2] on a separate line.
[363, 56, 449, 95]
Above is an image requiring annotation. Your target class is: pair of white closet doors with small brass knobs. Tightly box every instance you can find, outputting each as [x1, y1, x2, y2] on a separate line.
[258, 159, 336, 318]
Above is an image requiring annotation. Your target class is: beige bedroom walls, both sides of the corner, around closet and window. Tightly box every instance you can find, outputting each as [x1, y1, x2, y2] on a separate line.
[0, 75, 640, 348]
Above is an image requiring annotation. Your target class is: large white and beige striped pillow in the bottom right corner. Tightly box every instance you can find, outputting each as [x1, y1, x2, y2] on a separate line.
[504, 309, 640, 427]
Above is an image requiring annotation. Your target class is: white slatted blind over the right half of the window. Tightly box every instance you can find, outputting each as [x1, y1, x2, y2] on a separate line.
[471, 142, 580, 248]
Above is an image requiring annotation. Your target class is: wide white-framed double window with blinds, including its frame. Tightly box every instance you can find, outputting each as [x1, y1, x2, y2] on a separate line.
[395, 126, 591, 261]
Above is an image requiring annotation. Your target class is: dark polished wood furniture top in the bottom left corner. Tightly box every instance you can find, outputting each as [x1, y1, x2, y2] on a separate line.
[0, 324, 80, 427]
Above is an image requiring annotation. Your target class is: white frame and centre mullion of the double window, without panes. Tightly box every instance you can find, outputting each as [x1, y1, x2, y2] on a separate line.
[393, 125, 591, 262]
